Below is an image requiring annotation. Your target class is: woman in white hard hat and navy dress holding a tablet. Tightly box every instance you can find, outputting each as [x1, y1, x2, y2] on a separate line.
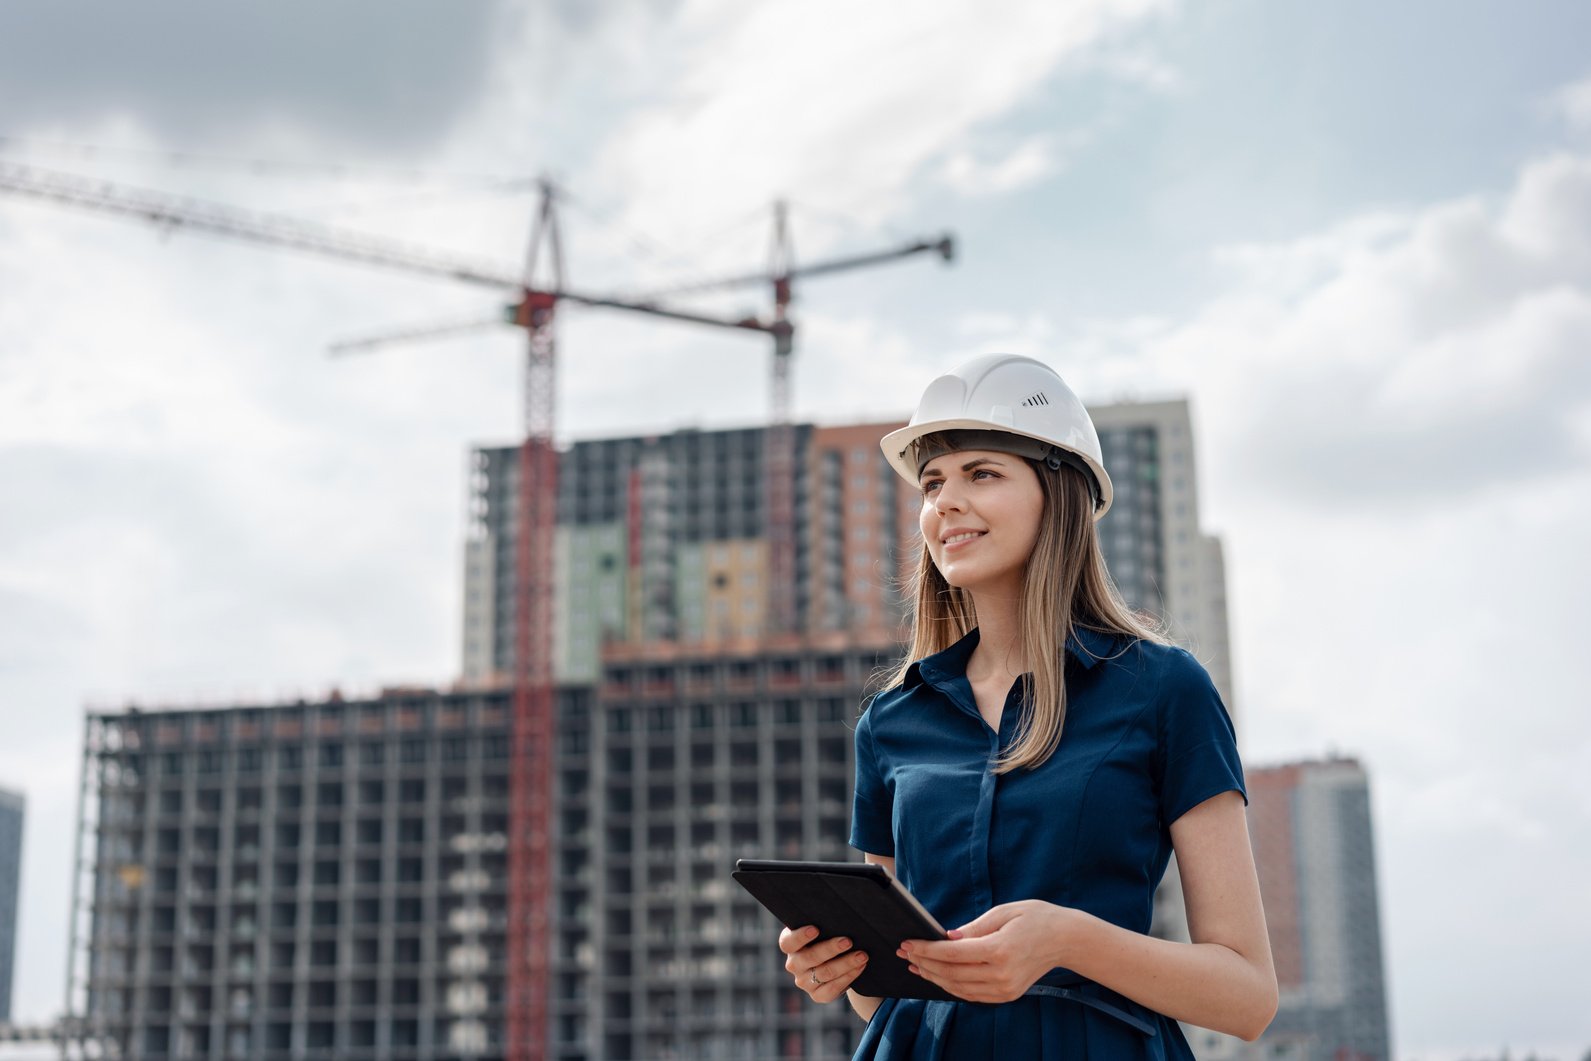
[780, 355, 1276, 1061]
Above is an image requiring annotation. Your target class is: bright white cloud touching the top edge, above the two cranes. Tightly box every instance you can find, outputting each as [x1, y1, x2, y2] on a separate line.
[601, 0, 1166, 272]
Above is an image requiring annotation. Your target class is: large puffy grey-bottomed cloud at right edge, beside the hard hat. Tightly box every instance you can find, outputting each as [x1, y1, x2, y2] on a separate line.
[1083, 154, 1591, 511]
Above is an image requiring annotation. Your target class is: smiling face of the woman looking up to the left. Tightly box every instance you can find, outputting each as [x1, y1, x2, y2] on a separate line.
[918, 450, 1044, 598]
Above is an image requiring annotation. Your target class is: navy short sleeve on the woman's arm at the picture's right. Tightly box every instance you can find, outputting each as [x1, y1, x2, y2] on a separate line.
[1157, 649, 1249, 826]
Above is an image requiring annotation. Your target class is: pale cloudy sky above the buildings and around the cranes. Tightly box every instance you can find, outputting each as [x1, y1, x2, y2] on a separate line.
[0, 0, 1591, 1061]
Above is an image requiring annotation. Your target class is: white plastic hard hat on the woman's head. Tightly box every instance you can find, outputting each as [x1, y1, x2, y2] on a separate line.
[878, 353, 1111, 520]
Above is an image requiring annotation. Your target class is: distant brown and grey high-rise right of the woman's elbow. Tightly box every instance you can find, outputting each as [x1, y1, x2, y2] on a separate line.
[1249, 759, 1392, 1061]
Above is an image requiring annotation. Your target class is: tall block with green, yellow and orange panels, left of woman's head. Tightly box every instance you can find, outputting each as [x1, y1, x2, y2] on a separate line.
[463, 425, 915, 682]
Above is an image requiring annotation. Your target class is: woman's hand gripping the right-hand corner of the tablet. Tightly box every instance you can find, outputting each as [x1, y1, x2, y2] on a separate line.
[896, 899, 1077, 1002]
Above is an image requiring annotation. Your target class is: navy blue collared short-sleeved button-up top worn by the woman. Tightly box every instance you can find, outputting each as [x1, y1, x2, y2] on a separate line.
[851, 630, 1244, 1056]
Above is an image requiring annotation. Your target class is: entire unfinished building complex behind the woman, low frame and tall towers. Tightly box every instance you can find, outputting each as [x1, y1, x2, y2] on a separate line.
[70, 402, 1230, 1061]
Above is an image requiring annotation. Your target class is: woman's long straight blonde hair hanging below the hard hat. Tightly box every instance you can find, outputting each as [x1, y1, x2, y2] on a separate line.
[886, 436, 1166, 773]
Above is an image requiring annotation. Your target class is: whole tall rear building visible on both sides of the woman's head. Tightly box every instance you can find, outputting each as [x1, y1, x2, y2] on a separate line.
[463, 401, 1233, 708]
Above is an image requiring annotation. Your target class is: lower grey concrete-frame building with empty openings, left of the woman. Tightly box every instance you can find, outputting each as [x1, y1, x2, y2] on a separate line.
[73, 635, 893, 1061]
